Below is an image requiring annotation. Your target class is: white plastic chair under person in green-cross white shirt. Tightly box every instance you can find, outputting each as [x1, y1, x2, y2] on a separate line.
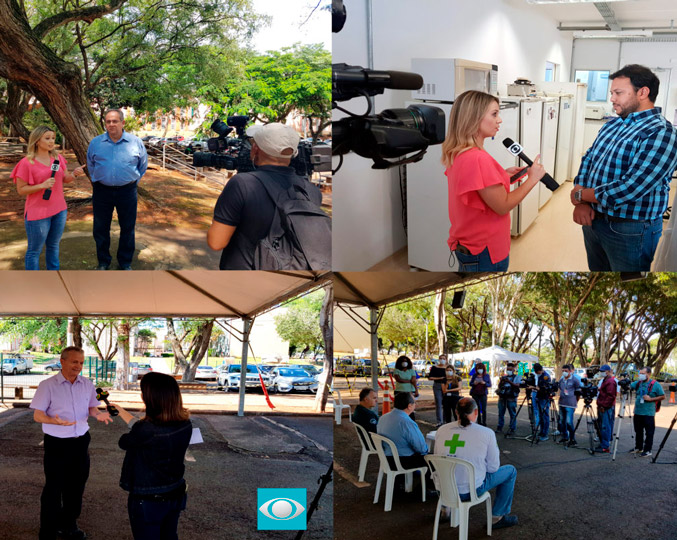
[425, 455, 492, 540]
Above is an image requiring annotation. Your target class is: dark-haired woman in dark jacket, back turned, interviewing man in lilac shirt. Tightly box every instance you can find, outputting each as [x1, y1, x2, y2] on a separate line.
[112, 372, 193, 540]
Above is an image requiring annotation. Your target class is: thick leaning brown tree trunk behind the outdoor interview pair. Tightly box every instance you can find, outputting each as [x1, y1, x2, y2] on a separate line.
[0, 0, 100, 163]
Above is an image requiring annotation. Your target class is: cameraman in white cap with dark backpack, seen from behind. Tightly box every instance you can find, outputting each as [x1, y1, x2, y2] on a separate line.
[207, 123, 331, 270]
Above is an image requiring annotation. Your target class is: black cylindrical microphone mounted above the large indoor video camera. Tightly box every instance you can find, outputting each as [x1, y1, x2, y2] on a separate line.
[331, 64, 423, 101]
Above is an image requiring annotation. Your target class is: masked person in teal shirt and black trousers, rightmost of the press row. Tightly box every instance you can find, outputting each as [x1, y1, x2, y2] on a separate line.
[630, 368, 665, 457]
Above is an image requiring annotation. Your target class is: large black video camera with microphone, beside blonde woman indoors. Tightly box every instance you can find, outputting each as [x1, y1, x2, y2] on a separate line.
[331, 0, 446, 172]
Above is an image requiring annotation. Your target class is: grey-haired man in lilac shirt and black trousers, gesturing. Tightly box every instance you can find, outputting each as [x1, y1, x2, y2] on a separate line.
[30, 347, 112, 540]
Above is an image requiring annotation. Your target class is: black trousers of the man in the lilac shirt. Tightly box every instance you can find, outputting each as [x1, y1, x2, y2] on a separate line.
[39, 432, 91, 540]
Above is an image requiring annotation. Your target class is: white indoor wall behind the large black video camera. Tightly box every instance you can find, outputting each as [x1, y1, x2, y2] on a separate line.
[332, 0, 572, 271]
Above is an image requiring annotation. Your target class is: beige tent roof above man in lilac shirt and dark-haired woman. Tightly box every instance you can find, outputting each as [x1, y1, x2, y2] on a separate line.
[0, 270, 331, 318]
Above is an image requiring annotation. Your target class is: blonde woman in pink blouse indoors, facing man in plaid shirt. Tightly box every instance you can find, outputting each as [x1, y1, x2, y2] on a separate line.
[442, 90, 545, 272]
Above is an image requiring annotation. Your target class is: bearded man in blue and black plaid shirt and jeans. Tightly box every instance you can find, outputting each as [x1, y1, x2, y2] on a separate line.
[571, 64, 677, 272]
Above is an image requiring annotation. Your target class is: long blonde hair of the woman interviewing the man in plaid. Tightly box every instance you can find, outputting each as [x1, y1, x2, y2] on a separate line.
[442, 90, 499, 167]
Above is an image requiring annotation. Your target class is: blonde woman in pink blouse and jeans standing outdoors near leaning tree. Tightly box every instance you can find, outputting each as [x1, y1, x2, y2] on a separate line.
[11, 126, 83, 270]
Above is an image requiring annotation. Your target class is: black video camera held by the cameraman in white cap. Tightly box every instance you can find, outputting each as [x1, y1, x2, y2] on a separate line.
[193, 116, 331, 176]
